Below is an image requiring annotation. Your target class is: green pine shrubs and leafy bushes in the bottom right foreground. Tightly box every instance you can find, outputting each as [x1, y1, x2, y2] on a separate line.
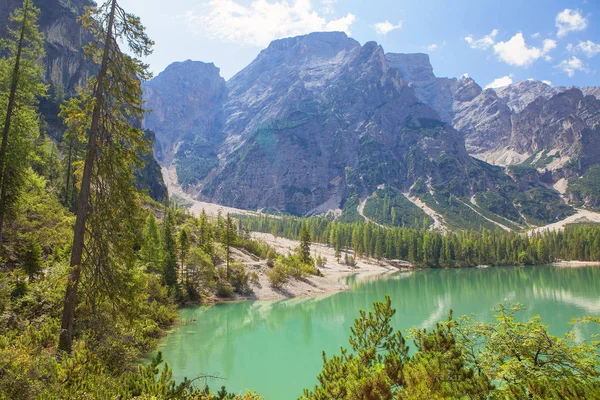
[302, 296, 600, 400]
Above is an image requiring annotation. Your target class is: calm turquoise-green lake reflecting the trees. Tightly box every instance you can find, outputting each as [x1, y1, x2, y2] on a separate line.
[149, 266, 600, 400]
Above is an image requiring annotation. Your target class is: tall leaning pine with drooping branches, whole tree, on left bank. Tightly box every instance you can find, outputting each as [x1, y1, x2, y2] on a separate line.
[59, 0, 153, 352]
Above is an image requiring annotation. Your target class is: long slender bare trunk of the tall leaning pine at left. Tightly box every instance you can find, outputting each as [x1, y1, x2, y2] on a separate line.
[58, 0, 117, 353]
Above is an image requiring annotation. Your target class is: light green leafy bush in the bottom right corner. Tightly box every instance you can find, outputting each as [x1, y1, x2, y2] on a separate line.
[448, 304, 600, 399]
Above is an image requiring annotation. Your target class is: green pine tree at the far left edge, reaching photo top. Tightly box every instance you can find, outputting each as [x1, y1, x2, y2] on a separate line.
[0, 0, 47, 245]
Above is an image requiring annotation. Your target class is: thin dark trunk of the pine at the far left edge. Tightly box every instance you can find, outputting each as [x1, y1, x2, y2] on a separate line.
[0, 0, 31, 246]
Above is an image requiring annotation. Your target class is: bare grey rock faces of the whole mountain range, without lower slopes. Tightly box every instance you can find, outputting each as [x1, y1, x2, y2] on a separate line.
[145, 32, 597, 215]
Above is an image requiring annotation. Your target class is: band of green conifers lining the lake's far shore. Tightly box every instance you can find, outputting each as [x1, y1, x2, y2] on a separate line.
[239, 216, 600, 268]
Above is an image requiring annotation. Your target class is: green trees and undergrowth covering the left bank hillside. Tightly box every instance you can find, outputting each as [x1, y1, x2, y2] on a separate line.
[0, 0, 263, 399]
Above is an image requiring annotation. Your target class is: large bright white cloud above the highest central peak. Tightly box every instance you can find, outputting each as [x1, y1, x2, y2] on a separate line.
[184, 0, 356, 46]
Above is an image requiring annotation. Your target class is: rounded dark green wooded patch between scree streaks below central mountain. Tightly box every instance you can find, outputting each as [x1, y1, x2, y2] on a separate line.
[364, 187, 433, 228]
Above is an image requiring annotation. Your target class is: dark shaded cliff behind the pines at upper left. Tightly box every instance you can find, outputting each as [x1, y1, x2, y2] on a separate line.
[0, 0, 166, 200]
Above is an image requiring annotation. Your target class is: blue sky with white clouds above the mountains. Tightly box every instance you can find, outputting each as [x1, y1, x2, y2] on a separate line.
[120, 0, 600, 87]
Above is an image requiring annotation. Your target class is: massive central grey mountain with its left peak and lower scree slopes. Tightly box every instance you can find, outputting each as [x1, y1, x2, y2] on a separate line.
[144, 32, 570, 229]
